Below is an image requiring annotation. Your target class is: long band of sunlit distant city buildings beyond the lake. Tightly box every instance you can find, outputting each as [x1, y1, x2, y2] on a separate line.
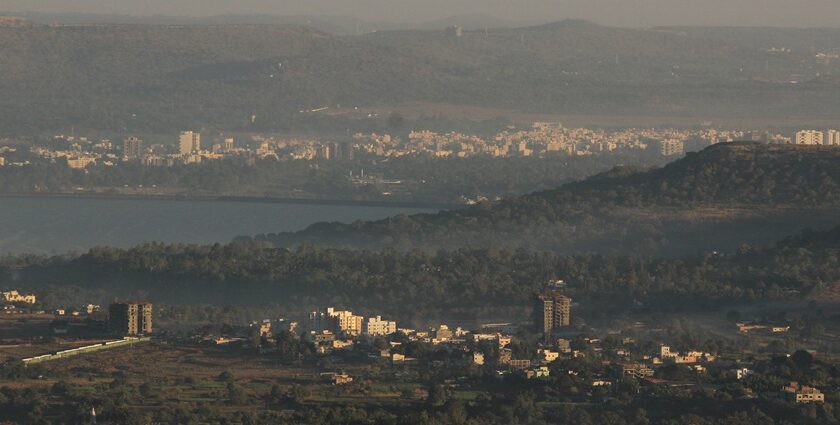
[0, 122, 840, 169]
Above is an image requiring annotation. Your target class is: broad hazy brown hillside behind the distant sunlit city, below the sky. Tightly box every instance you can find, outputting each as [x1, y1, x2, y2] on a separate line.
[0, 21, 840, 132]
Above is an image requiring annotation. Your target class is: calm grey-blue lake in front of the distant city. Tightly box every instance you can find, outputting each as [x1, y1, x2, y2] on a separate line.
[0, 197, 437, 254]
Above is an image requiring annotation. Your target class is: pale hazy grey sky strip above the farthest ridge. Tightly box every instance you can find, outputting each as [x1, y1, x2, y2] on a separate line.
[0, 0, 840, 27]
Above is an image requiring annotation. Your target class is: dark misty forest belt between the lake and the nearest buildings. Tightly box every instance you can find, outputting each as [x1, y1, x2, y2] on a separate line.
[0, 220, 840, 320]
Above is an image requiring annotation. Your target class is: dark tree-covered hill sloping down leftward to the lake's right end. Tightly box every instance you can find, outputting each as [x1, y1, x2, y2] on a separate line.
[254, 143, 840, 255]
